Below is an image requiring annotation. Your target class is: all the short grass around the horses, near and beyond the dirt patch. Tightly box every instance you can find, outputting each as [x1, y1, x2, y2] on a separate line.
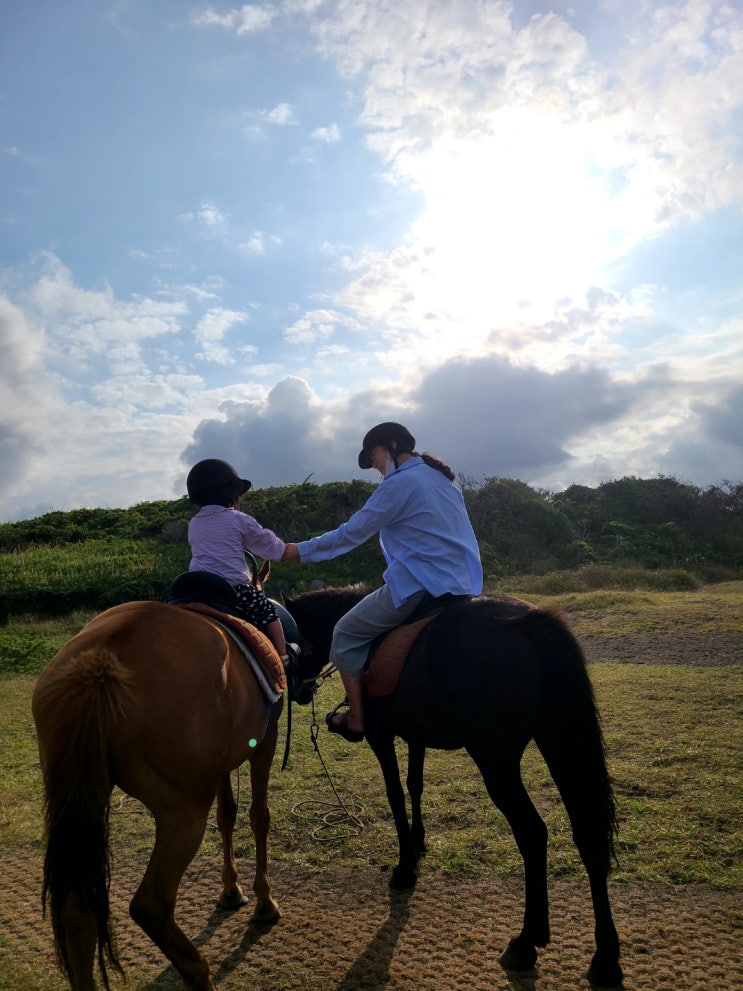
[0, 582, 743, 991]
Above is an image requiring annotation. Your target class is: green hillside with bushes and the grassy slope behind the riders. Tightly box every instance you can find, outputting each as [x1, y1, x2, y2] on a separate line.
[0, 477, 743, 623]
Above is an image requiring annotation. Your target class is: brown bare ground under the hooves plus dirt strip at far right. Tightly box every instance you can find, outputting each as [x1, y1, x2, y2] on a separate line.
[0, 634, 743, 991]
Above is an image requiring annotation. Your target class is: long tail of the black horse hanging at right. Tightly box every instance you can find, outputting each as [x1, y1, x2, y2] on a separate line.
[527, 609, 617, 874]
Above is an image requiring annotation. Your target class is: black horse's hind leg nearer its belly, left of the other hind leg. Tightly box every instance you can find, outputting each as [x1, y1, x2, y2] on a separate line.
[470, 751, 550, 971]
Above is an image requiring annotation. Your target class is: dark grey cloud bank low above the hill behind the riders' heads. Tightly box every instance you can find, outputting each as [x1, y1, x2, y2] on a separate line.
[183, 357, 638, 494]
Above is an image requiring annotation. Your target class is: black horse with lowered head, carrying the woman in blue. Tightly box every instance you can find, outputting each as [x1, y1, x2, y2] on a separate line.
[286, 588, 622, 987]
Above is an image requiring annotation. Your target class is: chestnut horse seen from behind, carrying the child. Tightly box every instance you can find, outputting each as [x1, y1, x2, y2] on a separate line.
[32, 602, 283, 991]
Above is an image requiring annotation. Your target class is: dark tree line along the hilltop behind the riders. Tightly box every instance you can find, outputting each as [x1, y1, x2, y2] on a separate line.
[0, 476, 743, 581]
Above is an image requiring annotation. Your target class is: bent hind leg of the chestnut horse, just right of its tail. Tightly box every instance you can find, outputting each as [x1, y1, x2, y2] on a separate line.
[129, 806, 215, 991]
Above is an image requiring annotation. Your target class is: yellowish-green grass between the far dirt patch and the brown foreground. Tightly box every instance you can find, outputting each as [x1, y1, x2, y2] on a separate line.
[0, 664, 743, 889]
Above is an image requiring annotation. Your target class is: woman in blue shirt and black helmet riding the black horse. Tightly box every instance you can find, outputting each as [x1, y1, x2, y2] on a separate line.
[282, 422, 482, 743]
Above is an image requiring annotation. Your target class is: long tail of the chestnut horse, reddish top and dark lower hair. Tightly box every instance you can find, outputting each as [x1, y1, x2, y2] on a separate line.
[33, 648, 130, 989]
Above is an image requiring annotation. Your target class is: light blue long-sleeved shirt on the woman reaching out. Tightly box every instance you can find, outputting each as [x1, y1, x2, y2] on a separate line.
[297, 457, 482, 606]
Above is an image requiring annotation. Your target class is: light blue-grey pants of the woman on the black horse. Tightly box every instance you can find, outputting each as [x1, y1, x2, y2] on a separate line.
[330, 585, 426, 678]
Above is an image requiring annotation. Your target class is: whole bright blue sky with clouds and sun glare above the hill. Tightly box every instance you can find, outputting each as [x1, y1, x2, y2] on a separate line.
[0, 0, 743, 522]
